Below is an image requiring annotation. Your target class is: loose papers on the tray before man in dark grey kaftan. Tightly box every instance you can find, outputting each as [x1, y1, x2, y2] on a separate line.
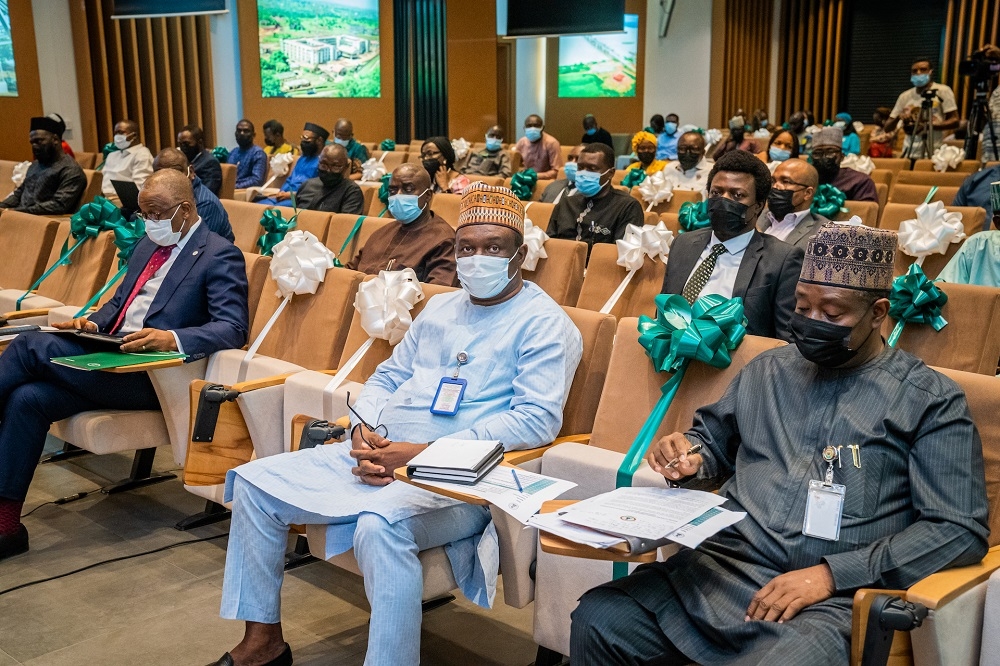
[528, 488, 746, 555]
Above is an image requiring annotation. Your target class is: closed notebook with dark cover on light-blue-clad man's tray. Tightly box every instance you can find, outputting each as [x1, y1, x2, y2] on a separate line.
[406, 437, 503, 484]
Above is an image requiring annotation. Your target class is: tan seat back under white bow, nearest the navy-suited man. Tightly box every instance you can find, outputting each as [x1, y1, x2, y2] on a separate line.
[250, 268, 364, 370]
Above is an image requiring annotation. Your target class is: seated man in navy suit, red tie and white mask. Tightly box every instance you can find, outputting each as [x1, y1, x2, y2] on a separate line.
[0, 169, 250, 560]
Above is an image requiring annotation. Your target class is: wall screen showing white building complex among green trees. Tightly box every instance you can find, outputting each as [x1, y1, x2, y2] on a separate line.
[257, 0, 381, 98]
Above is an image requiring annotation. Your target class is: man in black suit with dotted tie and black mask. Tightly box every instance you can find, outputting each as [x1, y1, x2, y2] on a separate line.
[662, 150, 803, 340]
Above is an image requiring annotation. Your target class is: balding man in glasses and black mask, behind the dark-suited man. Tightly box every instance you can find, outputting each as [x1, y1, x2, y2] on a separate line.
[757, 160, 830, 251]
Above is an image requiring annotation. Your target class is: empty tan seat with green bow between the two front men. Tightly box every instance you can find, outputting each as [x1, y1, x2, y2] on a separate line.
[536, 318, 785, 654]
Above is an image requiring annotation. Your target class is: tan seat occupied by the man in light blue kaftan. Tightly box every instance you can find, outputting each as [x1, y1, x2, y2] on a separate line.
[307, 308, 614, 608]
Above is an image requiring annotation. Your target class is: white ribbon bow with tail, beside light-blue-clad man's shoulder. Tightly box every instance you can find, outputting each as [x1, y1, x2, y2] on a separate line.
[323, 268, 424, 400]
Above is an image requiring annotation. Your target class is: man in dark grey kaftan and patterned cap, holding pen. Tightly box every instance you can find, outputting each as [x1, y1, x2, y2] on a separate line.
[570, 225, 990, 666]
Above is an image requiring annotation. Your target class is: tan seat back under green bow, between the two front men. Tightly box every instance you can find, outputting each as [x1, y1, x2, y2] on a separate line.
[590, 317, 785, 453]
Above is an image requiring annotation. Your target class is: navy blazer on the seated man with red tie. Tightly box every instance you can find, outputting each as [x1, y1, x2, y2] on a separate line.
[89, 224, 250, 361]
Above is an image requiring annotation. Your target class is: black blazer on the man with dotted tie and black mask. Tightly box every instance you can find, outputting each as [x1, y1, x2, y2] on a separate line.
[661, 229, 804, 341]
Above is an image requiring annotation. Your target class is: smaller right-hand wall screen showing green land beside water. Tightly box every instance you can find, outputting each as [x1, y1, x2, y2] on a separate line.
[559, 14, 639, 97]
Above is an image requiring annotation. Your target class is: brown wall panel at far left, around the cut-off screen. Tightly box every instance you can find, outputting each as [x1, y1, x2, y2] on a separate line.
[0, 0, 44, 162]
